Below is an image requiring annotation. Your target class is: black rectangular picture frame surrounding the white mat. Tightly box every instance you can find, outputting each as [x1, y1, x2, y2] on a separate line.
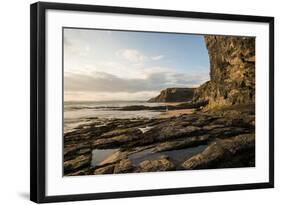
[30, 2, 274, 203]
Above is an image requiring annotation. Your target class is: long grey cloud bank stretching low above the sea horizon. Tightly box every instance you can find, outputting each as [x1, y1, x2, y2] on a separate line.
[64, 69, 207, 93]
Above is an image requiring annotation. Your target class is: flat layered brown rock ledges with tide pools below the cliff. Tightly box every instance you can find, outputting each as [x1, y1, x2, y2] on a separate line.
[64, 104, 255, 176]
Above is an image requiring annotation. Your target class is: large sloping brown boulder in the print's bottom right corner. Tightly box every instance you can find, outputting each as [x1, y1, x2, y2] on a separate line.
[182, 134, 255, 169]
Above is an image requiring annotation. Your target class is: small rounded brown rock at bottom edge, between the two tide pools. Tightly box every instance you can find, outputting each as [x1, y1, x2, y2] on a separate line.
[138, 158, 175, 172]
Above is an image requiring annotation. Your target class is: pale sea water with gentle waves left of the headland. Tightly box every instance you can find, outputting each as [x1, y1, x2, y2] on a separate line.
[64, 101, 166, 133]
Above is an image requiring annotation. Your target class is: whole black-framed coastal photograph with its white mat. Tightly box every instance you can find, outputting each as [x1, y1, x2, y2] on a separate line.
[30, 2, 274, 203]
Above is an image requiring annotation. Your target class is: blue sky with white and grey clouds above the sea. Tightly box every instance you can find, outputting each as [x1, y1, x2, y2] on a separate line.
[63, 28, 209, 101]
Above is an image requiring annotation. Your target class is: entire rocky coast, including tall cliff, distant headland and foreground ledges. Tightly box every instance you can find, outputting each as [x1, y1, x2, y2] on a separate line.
[64, 35, 255, 176]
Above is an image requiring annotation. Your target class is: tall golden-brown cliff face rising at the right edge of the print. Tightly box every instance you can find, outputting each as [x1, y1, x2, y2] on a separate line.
[193, 35, 255, 105]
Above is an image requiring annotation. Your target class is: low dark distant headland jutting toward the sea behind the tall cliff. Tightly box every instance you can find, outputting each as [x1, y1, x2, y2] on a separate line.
[148, 88, 194, 102]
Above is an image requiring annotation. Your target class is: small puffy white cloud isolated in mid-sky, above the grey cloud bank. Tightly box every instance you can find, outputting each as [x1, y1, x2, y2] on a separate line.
[116, 49, 147, 63]
